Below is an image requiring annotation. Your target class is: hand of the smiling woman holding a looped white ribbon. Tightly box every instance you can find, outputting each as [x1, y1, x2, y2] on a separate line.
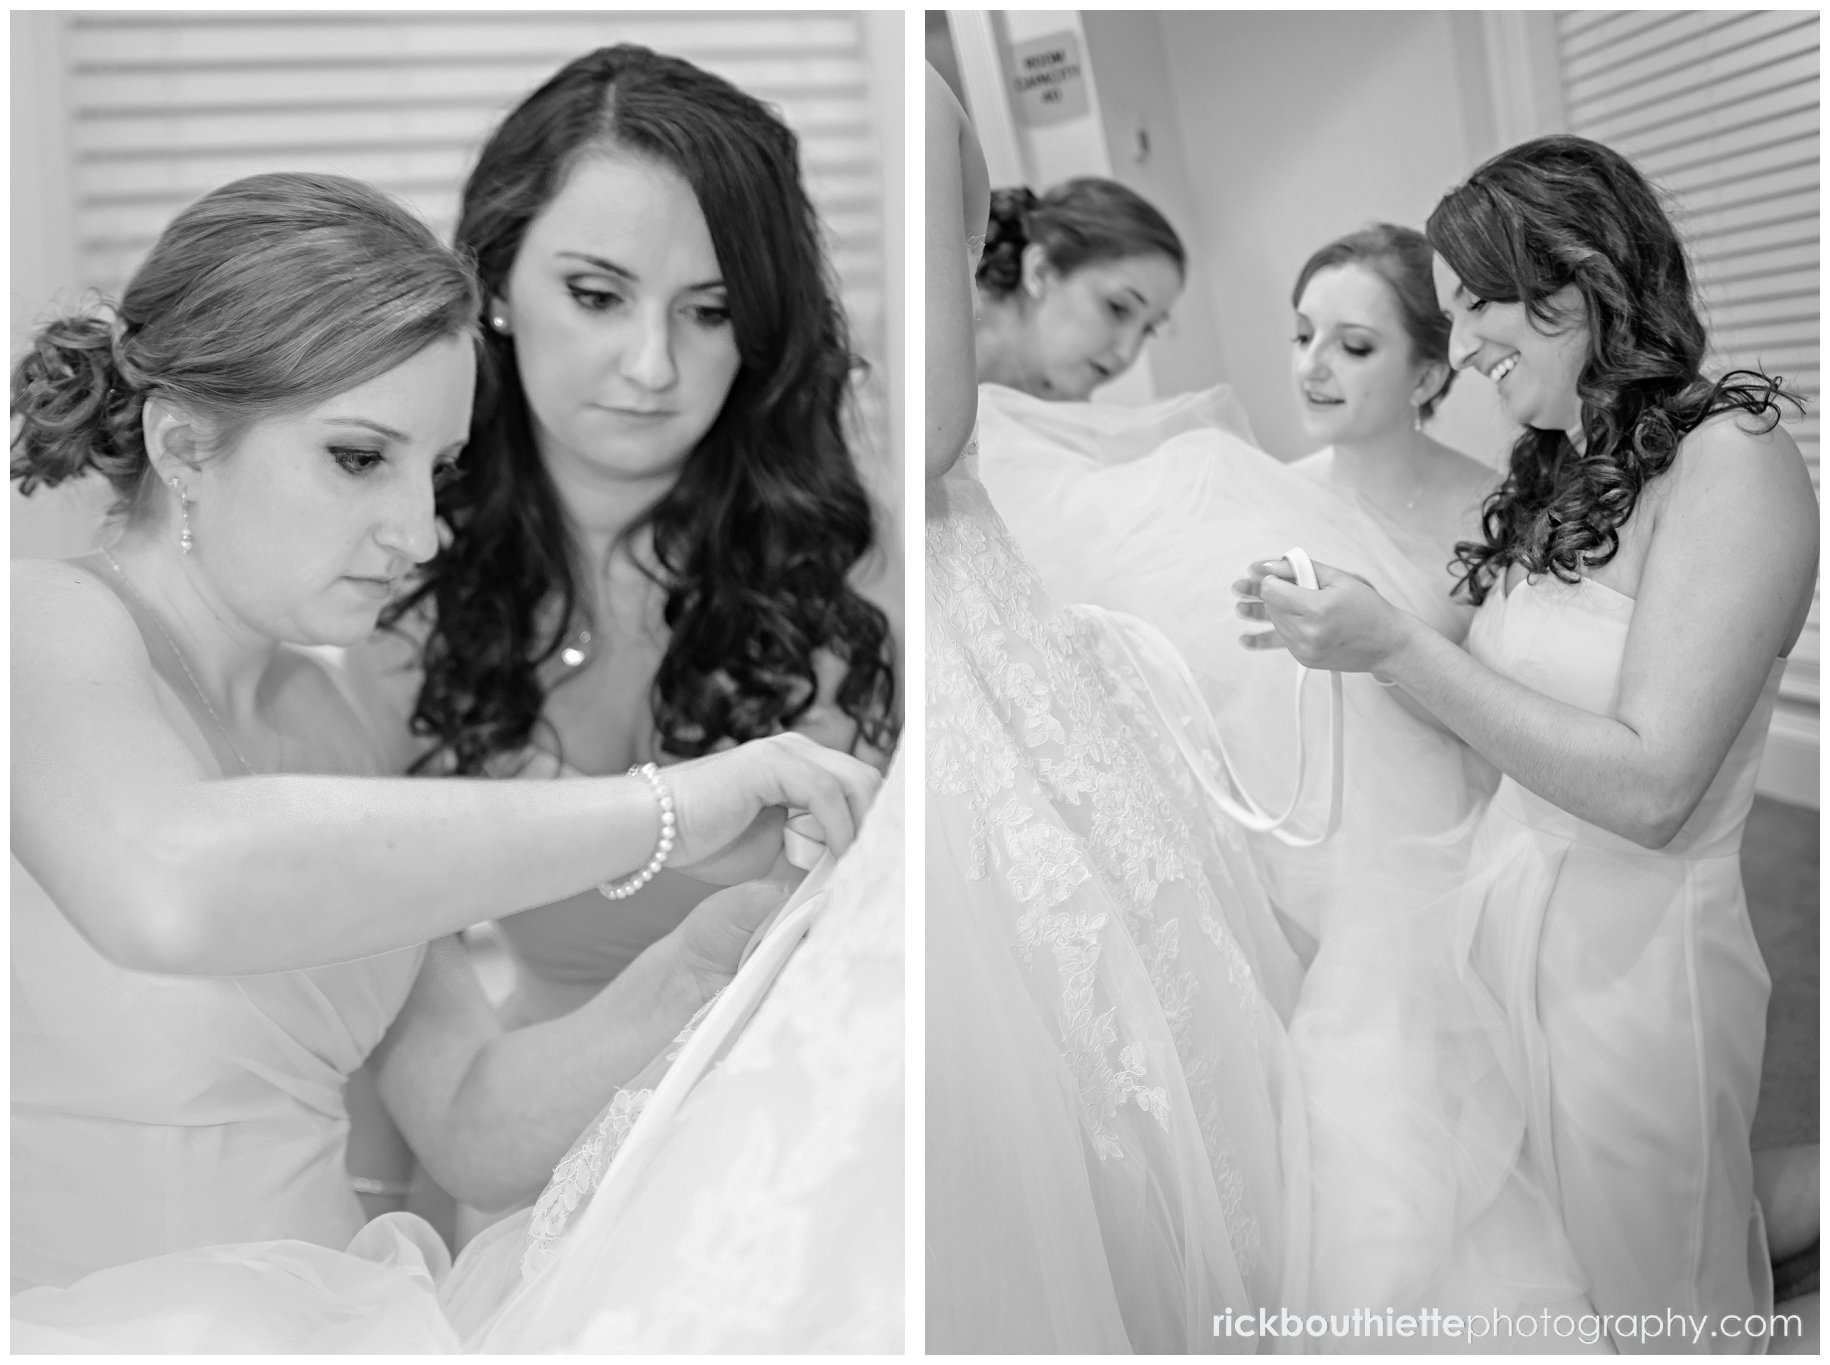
[1233, 560, 1413, 673]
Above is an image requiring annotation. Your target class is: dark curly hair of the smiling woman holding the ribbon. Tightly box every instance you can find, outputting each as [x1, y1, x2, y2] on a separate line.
[1426, 134, 1803, 606]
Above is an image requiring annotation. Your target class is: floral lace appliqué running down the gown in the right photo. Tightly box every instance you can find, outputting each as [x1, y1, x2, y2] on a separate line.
[928, 462, 1272, 1268]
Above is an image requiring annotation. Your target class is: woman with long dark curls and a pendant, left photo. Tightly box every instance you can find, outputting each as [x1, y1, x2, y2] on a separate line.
[357, 46, 897, 1023]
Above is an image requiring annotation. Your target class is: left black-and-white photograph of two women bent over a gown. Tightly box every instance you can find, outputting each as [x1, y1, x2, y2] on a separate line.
[11, 9, 900, 1354]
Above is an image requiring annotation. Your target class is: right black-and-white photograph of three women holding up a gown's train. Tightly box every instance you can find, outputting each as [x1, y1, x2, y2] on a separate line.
[922, 9, 1821, 1354]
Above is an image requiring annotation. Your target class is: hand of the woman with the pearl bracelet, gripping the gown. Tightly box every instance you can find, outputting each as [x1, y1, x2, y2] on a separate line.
[664, 734, 882, 884]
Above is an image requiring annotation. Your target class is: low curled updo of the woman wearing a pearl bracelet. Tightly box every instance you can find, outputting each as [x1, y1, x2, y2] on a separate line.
[13, 172, 478, 512]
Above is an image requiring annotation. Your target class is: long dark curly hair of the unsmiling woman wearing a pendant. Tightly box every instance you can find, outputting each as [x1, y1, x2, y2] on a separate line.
[384, 44, 897, 774]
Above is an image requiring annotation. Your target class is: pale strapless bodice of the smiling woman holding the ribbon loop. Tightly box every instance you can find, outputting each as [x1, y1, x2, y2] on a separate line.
[1468, 575, 1786, 858]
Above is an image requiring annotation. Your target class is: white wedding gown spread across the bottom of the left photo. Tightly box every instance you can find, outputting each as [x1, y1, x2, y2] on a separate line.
[13, 750, 902, 1352]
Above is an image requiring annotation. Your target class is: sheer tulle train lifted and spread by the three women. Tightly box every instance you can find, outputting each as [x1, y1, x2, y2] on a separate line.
[979, 386, 1610, 1350]
